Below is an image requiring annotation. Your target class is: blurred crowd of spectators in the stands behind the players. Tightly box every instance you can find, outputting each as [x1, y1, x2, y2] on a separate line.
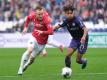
[0, 0, 107, 32]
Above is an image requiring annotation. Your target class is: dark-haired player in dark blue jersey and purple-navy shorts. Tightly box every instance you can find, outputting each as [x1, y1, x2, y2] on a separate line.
[54, 6, 88, 69]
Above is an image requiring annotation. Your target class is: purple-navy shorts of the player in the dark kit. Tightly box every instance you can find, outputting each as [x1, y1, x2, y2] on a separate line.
[69, 39, 88, 54]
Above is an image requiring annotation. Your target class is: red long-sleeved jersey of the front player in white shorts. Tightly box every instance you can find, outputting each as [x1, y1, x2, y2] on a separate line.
[25, 12, 53, 45]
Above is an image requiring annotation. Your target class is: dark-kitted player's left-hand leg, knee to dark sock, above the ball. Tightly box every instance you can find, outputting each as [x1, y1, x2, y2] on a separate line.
[65, 48, 75, 68]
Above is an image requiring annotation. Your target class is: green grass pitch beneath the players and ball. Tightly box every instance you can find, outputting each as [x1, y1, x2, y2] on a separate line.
[0, 48, 107, 80]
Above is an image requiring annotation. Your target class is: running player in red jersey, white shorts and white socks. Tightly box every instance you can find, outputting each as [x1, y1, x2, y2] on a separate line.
[18, 6, 53, 75]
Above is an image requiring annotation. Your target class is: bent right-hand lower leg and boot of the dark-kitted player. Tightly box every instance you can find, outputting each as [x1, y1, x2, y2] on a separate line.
[76, 53, 87, 69]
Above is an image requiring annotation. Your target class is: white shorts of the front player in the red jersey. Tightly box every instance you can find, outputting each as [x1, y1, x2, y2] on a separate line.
[28, 36, 45, 57]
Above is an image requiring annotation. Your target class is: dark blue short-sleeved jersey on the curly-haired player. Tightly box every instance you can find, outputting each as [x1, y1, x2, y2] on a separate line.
[59, 16, 88, 40]
